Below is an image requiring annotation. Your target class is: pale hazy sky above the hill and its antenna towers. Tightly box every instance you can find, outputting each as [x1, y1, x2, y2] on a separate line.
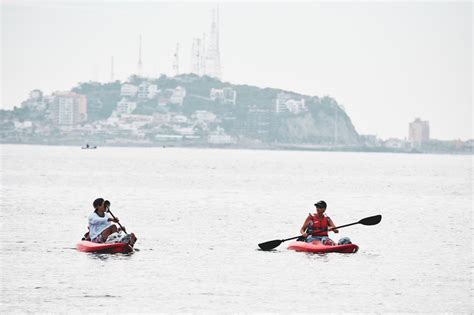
[1, 0, 473, 140]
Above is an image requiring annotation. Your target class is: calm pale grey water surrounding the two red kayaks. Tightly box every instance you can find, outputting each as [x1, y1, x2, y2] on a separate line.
[0, 145, 473, 313]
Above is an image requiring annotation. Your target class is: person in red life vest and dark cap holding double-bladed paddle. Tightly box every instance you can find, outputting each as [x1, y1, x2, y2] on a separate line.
[300, 200, 339, 245]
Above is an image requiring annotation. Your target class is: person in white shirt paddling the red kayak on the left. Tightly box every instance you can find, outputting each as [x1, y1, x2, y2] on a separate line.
[89, 198, 137, 246]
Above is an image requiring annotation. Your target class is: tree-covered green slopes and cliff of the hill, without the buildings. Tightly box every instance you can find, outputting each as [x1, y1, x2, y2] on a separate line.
[73, 74, 360, 146]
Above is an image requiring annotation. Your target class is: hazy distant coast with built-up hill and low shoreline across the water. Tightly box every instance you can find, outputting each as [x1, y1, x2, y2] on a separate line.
[4, 75, 474, 154]
